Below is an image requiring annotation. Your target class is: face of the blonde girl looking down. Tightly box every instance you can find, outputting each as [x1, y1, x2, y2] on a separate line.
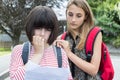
[66, 4, 85, 30]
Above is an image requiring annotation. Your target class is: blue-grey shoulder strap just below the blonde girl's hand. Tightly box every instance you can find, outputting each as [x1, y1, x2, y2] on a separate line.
[53, 46, 62, 68]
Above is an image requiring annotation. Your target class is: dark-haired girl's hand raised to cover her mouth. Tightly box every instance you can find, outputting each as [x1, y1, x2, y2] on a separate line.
[32, 36, 44, 53]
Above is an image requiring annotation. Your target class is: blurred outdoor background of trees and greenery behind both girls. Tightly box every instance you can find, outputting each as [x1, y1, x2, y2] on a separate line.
[0, 0, 120, 80]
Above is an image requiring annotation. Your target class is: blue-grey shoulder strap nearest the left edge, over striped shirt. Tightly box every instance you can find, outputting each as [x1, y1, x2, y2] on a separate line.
[22, 41, 31, 65]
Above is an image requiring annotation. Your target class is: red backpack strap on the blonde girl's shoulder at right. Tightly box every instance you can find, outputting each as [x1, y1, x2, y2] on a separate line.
[85, 26, 101, 62]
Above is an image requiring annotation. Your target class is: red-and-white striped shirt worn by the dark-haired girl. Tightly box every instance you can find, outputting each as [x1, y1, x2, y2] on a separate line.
[10, 45, 73, 80]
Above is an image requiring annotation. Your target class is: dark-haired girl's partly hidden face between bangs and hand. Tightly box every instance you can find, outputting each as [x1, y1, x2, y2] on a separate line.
[34, 28, 51, 42]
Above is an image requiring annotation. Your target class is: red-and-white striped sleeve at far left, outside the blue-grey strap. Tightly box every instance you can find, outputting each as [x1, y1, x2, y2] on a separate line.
[10, 45, 25, 80]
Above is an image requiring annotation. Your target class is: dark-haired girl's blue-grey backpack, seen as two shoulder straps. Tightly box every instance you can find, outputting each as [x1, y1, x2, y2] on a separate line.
[22, 41, 62, 68]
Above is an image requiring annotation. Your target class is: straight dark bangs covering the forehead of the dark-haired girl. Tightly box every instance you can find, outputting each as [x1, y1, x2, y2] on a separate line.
[33, 13, 54, 30]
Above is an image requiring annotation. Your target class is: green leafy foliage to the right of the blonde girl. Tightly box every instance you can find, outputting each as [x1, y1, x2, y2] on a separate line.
[87, 0, 120, 47]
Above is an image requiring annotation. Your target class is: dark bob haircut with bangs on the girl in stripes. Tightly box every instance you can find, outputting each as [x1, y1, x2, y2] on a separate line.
[25, 6, 58, 45]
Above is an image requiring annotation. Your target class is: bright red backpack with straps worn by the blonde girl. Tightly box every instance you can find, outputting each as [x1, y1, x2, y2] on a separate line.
[61, 27, 114, 80]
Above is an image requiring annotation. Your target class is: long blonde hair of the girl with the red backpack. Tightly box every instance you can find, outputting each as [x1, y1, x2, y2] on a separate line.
[66, 0, 94, 50]
